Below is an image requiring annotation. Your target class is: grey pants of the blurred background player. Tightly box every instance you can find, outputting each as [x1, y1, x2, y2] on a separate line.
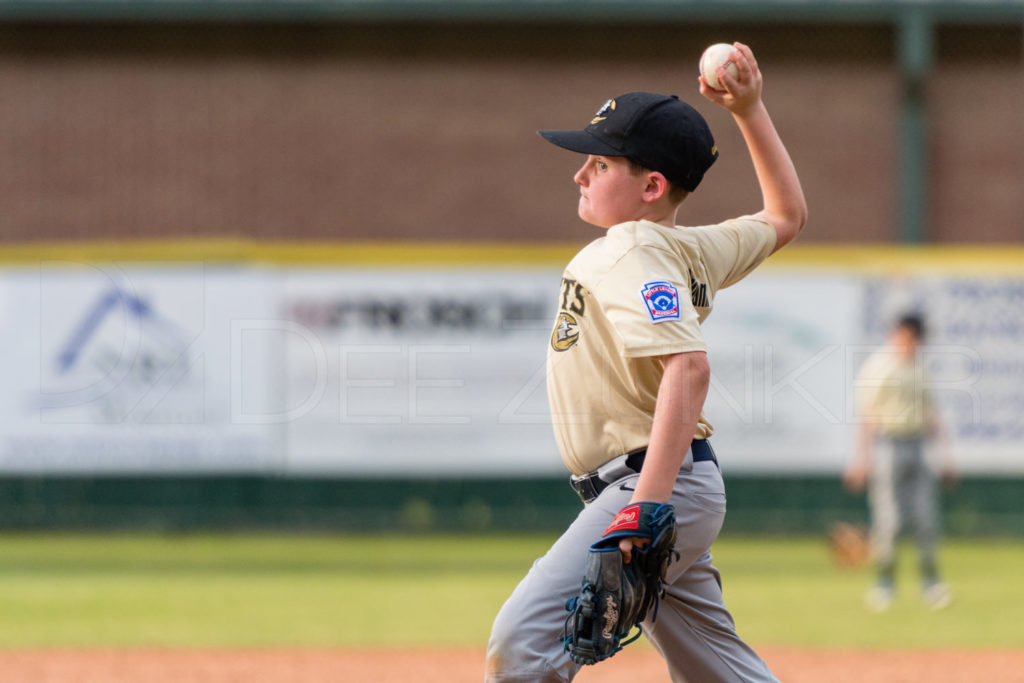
[868, 437, 939, 583]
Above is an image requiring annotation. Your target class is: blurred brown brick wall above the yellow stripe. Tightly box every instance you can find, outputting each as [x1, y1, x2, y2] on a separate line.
[0, 25, 1024, 243]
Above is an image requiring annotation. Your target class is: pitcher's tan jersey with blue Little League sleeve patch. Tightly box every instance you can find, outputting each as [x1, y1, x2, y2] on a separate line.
[548, 216, 775, 474]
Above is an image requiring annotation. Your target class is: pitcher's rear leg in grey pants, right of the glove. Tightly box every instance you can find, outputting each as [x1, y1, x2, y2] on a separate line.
[644, 463, 776, 683]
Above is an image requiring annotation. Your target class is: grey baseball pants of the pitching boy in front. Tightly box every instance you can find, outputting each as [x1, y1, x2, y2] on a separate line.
[484, 454, 776, 683]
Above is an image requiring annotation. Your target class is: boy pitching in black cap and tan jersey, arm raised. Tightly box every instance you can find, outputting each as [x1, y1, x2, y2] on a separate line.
[485, 43, 806, 683]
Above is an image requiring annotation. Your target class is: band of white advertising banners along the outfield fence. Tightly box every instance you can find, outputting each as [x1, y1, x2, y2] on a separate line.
[0, 263, 1024, 477]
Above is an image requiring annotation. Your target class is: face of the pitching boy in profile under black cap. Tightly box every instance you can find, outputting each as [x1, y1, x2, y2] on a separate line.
[572, 155, 646, 227]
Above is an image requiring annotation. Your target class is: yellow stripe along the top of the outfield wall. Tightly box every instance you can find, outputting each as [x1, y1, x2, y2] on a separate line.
[0, 240, 1024, 274]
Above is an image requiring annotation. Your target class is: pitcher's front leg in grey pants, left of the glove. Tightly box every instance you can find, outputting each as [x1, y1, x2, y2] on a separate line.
[484, 475, 636, 683]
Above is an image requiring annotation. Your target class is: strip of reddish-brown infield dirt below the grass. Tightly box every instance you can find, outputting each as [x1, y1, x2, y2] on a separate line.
[0, 647, 1024, 683]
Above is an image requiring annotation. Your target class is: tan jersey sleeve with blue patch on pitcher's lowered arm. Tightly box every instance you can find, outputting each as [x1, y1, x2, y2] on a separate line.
[594, 246, 707, 357]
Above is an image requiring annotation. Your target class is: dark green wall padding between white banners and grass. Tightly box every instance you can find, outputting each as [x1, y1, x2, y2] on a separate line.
[0, 475, 1024, 536]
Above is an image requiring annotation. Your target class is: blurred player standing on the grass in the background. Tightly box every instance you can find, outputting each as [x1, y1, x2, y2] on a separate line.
[844, 314, 955, 611]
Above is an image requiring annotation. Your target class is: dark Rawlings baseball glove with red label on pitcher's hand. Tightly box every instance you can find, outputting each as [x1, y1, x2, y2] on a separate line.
[562, 503, 676, 665]
